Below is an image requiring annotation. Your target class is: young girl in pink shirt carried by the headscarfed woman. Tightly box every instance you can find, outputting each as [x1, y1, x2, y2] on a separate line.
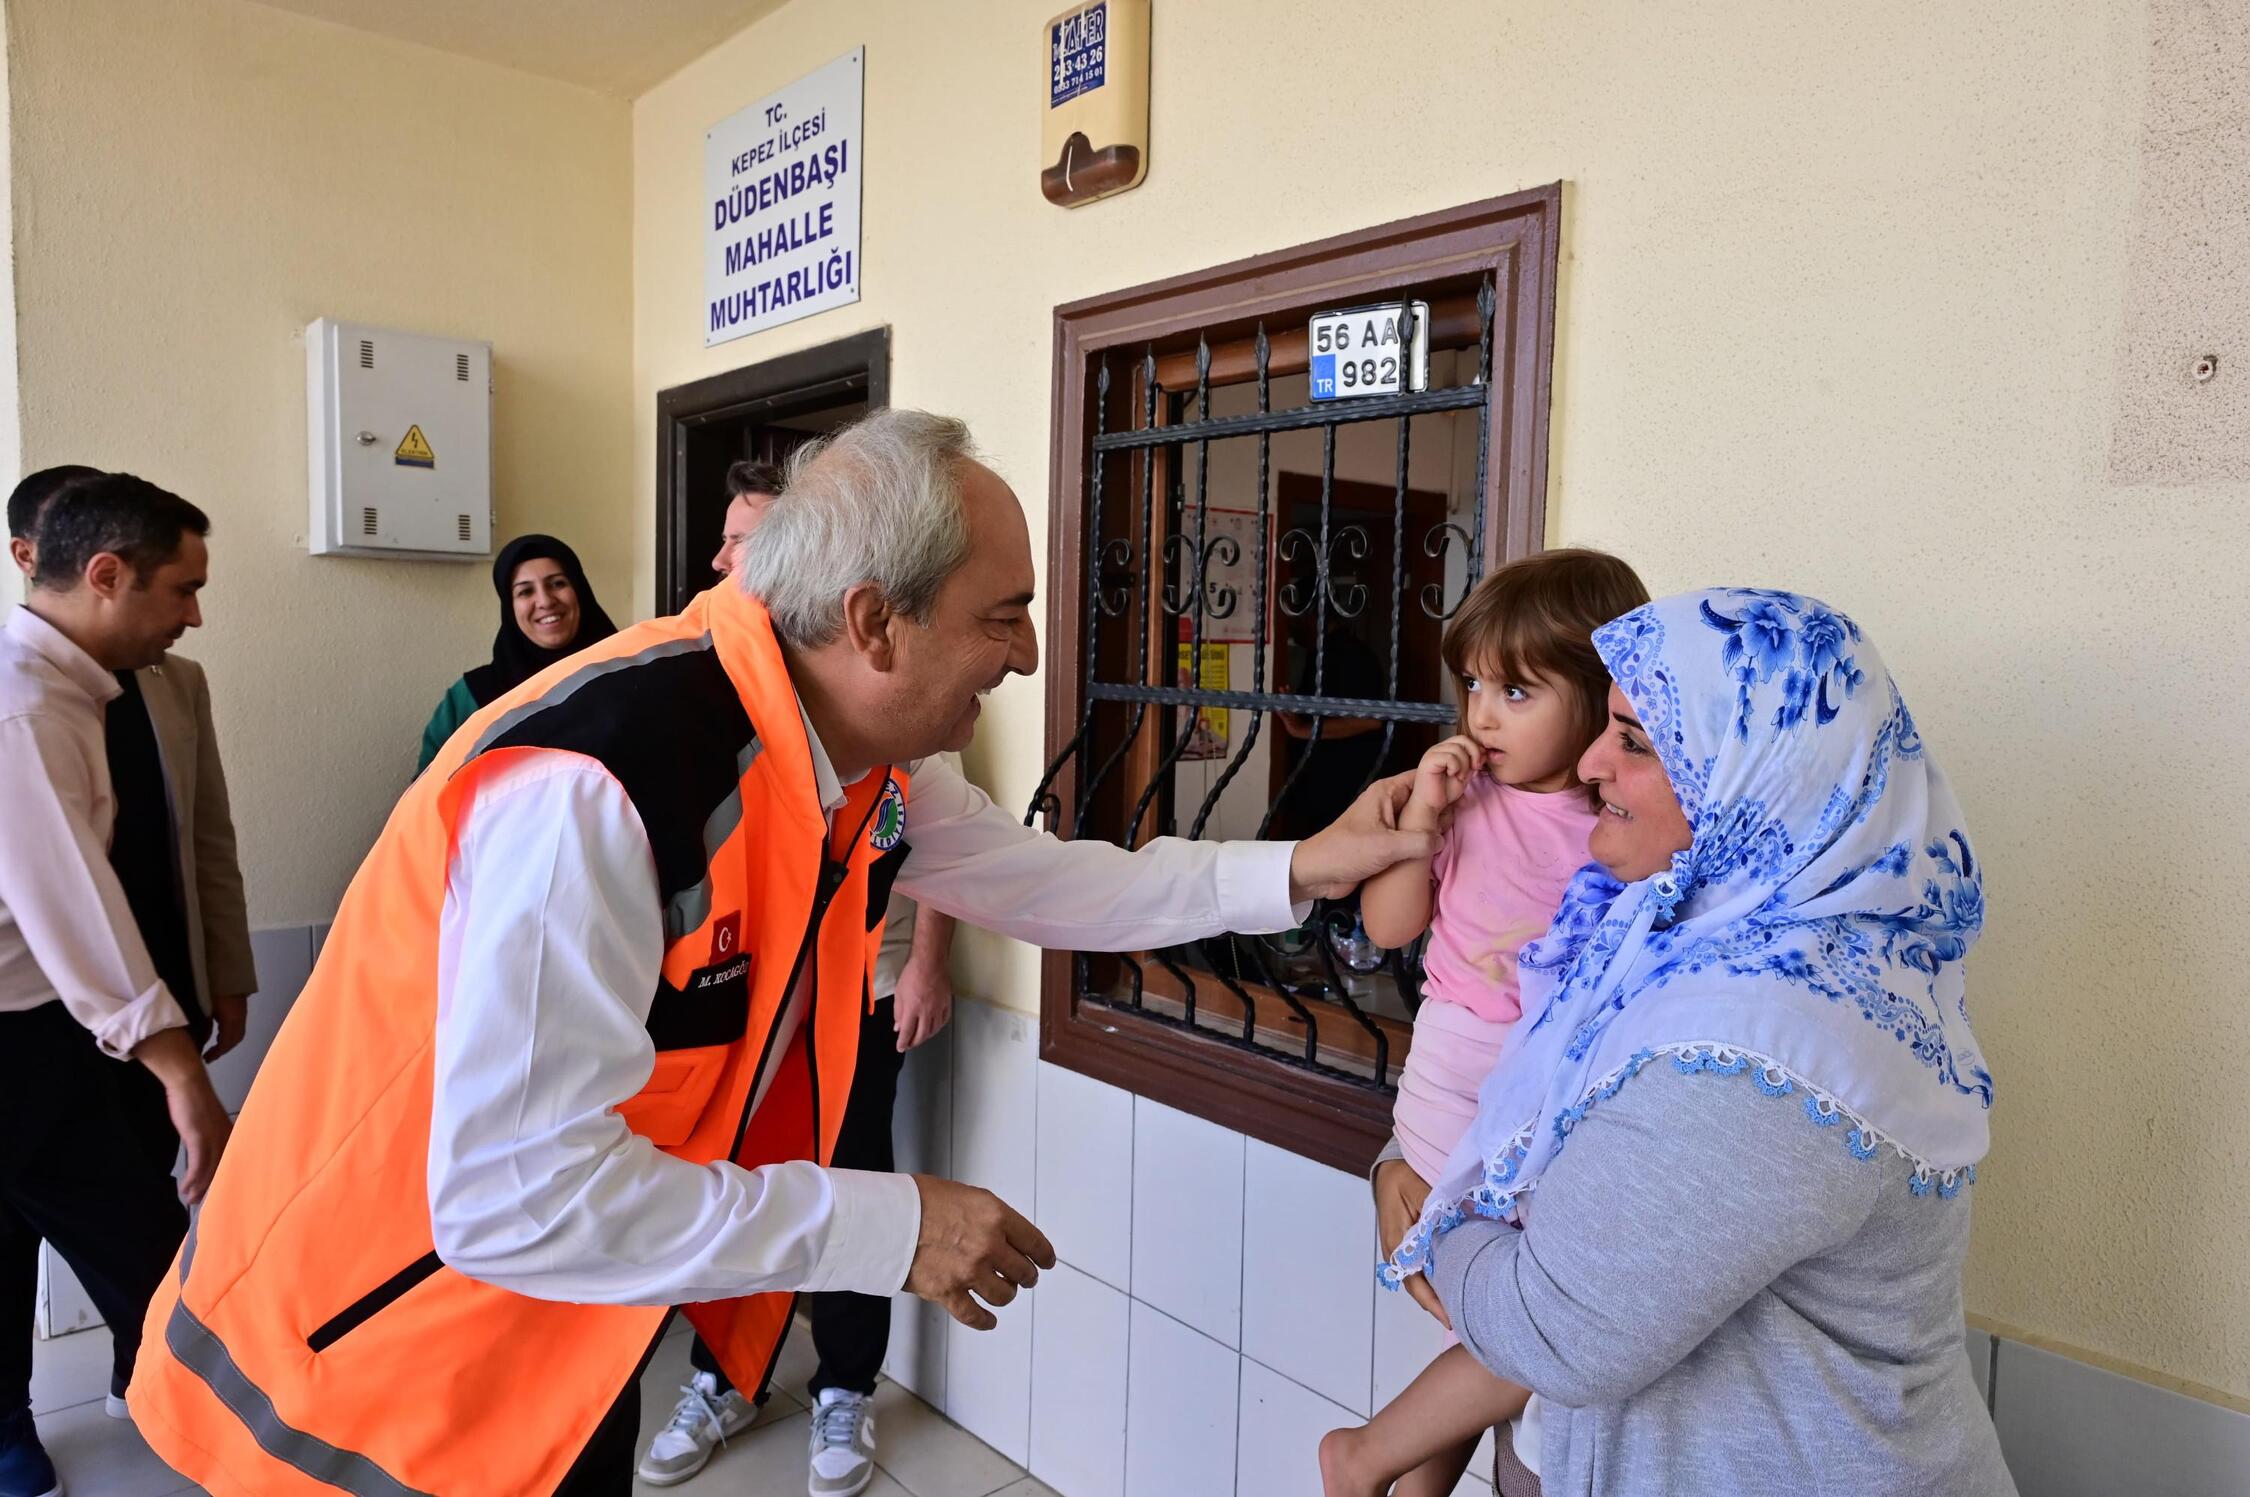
[1321, 549, 1649, 1497]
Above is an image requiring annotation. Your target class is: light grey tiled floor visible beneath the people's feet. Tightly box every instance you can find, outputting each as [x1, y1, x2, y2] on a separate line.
[32, 1319, 1055, 1497]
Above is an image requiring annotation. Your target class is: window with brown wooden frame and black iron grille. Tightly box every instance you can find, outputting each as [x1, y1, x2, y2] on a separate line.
[1026, 185, 1562, 1168]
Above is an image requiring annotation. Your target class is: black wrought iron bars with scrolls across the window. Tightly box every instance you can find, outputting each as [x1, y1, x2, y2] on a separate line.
[1024, 277, 1496, 1090]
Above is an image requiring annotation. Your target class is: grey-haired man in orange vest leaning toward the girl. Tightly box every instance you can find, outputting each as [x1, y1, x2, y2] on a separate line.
[131, 410, 1433, 1497]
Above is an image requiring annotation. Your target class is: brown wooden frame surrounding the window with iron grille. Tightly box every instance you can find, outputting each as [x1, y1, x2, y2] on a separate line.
[1040, 182, 1562, 1171]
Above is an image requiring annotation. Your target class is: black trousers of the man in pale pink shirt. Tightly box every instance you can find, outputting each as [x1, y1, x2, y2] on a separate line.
[0, 1002, 187, 1414]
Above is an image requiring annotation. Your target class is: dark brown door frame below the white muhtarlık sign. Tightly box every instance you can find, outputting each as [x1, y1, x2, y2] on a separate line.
[657, 326, 891, 610]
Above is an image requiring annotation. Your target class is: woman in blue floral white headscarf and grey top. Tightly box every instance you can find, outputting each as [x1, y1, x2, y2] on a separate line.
[1382, 590, 2016, 1497]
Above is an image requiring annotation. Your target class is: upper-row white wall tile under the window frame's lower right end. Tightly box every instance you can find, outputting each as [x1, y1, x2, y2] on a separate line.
[1242, 1139, 1375, 1418]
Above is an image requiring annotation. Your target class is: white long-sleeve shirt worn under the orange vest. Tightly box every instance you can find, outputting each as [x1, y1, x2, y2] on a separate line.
[430, 723, 1303, 1306]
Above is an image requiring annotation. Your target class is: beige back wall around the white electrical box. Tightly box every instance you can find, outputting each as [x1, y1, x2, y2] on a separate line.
[7, 0, 646, 925]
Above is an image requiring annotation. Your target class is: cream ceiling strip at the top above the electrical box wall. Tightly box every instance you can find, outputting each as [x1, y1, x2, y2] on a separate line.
[261, 0, 788, 99]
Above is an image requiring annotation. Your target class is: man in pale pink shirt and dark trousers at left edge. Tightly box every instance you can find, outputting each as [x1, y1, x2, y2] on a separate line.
[0, 475, 227, 1490]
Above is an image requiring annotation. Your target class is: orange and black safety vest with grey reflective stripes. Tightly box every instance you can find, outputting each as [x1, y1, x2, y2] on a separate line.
[131, 588, 907, 1497]
